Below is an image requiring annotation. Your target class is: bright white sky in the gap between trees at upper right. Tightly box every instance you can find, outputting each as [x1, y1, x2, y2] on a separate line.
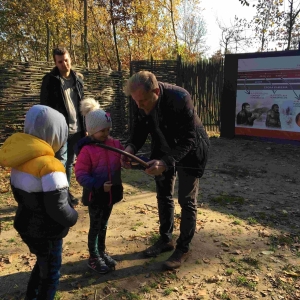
[201, 0, 257, 56]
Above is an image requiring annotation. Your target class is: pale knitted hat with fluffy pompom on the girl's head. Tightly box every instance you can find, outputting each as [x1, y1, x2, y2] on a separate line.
[80, 98, 112, 135]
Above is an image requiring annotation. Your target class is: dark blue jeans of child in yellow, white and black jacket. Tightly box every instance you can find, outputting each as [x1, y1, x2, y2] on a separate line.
[23, 239, 62, 300]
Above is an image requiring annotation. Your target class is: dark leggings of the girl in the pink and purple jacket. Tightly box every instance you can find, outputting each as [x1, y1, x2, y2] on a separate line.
[88, 199, 113, 257]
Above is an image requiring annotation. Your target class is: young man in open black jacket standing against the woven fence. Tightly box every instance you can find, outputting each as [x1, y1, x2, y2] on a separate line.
[40, 47, 85, 202]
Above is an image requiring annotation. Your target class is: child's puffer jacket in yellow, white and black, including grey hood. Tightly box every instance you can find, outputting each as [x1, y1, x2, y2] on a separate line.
[0, 105, 78, 240]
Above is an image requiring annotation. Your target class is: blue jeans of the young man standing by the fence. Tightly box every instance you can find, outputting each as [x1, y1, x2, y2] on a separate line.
[55, 132, 83, 185]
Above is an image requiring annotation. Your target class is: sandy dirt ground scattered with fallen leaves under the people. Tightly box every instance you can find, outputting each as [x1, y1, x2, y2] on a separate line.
[0, 138, 300, 300]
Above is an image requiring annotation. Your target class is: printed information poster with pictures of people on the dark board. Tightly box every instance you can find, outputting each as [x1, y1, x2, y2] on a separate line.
[235, 56, 300, 140]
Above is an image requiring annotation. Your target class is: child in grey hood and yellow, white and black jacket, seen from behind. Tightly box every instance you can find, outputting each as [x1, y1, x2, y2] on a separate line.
[0, 105, 78, 300]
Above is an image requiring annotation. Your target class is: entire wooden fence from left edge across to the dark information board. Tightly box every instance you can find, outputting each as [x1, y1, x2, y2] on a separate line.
[0, 57, 223, 144]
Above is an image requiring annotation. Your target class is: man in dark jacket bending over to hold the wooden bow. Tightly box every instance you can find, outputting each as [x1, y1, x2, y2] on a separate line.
[122, 71, 209, 270]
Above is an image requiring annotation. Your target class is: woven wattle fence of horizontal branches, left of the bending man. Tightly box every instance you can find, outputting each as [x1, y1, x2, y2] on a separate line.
[0, 61, 129, 144]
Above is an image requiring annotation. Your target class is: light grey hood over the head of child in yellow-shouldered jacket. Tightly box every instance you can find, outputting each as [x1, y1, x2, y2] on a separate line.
[24, 105, 68, 153]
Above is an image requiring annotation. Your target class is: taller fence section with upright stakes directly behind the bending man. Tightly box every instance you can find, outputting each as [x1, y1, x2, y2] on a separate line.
[130, 57, 224, 132]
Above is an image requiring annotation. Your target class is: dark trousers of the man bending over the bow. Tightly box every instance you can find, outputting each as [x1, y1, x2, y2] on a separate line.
[156, 169, 199, 253]
